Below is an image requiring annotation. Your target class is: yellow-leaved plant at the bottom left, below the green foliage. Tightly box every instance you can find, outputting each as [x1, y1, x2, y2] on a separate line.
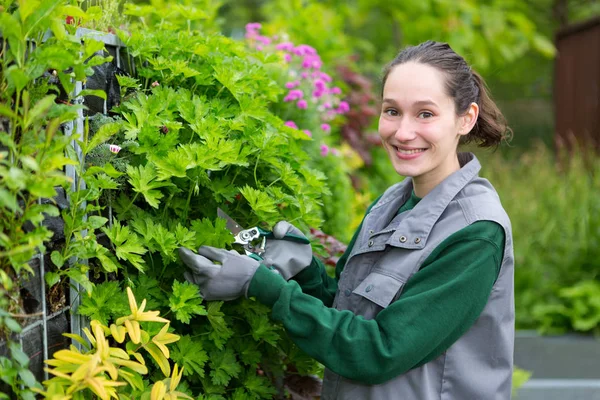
[36, 288, 190, 400]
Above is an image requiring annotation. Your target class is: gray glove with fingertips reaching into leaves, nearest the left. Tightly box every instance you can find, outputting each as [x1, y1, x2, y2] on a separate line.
[179, 246, 260, 300]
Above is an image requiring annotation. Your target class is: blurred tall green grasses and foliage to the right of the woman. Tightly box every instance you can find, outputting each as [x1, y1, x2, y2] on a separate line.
[480, 142, 600, 332]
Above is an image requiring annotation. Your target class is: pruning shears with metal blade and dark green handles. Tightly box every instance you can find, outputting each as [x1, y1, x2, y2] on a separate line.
[217, 208, 310, 261]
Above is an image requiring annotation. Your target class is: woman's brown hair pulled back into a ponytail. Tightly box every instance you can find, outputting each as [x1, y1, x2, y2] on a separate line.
[381, 41, 512, 147]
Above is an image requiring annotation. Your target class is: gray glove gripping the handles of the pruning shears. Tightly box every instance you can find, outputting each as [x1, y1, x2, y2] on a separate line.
[262, 221, 312, 281]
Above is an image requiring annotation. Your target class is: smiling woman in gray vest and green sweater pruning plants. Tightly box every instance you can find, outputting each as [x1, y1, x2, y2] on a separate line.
[181, 42, 514, 400]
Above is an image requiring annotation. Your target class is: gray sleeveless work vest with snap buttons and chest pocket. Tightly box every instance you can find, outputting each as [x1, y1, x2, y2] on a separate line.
[322, 153, 515, 400]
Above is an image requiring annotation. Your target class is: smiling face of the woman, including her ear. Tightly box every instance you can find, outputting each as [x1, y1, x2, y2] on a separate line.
[379, 62, 478, 188]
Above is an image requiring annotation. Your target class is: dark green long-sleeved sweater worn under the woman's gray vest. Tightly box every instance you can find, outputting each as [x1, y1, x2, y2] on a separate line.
[248, 194, 505, 384]
